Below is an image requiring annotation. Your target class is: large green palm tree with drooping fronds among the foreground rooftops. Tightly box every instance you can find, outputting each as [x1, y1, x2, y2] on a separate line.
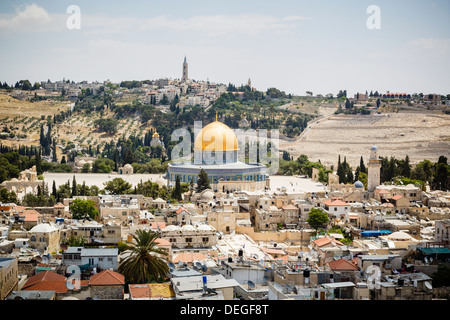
[119, 230, 169, 284]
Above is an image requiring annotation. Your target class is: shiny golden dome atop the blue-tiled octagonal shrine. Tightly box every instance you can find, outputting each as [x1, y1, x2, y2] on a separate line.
[194, 121, 238, 151]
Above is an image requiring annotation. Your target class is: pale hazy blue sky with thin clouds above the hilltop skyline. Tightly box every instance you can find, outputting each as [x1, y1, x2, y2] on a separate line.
[0, 0, 450, 95]
